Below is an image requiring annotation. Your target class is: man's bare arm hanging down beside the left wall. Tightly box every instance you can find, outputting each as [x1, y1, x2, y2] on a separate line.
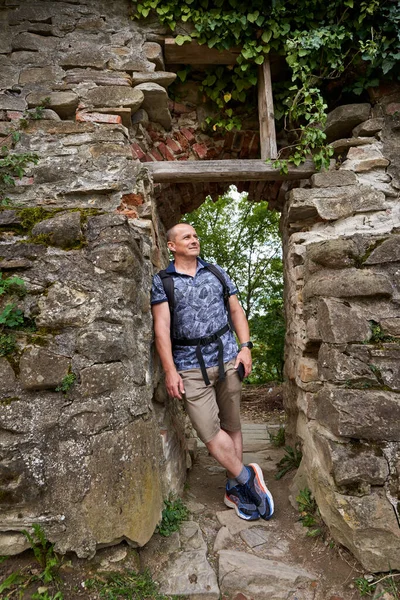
[151, 302, 185, 399]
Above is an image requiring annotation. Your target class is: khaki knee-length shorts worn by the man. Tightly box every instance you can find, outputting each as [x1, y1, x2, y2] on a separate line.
[179, 360, 242, 444]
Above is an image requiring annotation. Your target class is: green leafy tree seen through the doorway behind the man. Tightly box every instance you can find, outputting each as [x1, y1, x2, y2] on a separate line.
[183, 191, 285, 383]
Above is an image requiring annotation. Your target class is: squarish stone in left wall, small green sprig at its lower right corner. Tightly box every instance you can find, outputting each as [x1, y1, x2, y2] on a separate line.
[19, 347, 71, 391]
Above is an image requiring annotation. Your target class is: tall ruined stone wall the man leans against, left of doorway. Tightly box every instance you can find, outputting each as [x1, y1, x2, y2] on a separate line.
[0, 0, 187, 556]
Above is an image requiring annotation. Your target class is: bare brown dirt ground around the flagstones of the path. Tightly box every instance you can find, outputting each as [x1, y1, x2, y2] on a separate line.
[0, 386, 400, 600]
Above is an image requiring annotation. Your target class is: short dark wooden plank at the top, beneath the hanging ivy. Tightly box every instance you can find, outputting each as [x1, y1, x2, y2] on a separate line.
[164, 38, 240, 65]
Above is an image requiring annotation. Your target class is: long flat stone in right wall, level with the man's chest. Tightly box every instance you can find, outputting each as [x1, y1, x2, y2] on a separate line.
[303, 268, 393, 301]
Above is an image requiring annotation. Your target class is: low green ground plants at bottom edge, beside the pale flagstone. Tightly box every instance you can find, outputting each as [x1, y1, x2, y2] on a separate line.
[85, 571, 172, 600]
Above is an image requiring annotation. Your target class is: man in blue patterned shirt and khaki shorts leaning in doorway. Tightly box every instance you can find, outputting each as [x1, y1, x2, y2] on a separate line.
[151, 223, 274, 520]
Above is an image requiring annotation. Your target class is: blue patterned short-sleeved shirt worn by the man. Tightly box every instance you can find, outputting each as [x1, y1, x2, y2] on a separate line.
[151, 258, 238, 371]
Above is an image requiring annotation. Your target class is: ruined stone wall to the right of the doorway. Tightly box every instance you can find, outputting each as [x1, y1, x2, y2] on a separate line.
[283, 99, 400, 571]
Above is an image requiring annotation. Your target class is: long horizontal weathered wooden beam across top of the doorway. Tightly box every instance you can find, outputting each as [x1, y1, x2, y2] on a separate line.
[143, 160, 316, 183]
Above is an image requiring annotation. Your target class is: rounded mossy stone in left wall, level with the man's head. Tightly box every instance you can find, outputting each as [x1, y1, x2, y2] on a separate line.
[32, 212, 82, 248]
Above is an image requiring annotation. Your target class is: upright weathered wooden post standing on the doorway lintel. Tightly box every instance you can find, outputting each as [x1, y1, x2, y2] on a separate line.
[258, 57, 278, 160]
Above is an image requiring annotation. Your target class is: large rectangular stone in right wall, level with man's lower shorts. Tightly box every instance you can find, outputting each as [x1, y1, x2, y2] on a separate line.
[316, 386, 400, 442]
